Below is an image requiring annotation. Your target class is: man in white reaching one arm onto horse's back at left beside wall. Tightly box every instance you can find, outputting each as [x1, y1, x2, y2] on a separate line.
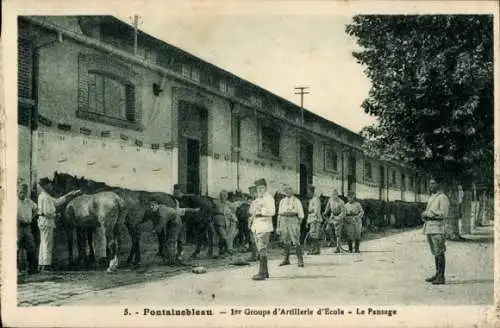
[38, 179, 81, 272]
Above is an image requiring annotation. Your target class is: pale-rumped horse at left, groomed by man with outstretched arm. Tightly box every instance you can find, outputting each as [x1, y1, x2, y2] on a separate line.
[64, 191, 127, 272]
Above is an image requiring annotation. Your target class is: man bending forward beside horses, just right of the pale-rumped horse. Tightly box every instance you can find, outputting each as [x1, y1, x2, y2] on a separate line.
[149, 201, 182, 265]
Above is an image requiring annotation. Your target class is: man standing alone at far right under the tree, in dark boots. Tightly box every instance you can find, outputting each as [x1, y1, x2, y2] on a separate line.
[422, 179, 450, 285]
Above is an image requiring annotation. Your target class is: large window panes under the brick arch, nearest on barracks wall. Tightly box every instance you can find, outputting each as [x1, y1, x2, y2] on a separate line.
[88, 73, 135, 122]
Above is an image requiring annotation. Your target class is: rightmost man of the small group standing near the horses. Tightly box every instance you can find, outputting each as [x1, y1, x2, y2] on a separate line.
[345, 191, 365, 253]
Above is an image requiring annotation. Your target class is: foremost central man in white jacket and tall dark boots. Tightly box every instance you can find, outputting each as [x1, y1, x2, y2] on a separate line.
[251, 179, 276, 280]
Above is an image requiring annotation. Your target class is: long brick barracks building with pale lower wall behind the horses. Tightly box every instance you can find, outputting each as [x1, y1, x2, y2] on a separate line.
[18, 16, 426, 201]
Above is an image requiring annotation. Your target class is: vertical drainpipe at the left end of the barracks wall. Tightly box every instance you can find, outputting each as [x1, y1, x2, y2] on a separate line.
[29, 31, 63, 192]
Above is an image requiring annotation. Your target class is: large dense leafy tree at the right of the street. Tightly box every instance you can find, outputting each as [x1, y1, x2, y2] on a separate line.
[346, 15, 494, 239]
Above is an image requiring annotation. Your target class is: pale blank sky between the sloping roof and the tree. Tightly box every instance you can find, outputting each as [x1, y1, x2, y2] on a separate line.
[119, 13, 375, 132]
